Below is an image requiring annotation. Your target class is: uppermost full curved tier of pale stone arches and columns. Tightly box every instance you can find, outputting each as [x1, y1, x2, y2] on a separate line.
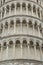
[0, 0, 43, 21]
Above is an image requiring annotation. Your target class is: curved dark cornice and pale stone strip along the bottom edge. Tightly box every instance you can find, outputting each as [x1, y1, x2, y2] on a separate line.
[0, 59, 43, 65]
